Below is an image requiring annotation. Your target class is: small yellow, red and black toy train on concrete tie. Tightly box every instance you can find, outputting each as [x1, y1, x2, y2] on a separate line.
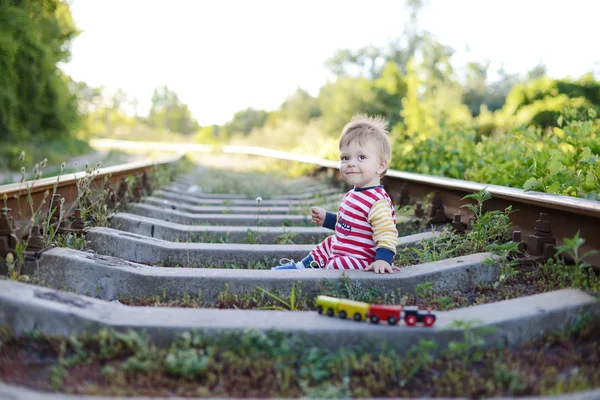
[317, 296, 436, 327]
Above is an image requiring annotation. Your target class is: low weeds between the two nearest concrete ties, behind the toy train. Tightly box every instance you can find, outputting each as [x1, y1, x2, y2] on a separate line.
[119, 248, 600, 311]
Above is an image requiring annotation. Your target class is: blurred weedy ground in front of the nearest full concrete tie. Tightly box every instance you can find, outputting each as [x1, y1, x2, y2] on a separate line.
[0, 314, 600, 398]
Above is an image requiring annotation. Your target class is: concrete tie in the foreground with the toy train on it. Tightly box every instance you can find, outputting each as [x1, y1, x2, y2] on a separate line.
[0, 281, 600, 353]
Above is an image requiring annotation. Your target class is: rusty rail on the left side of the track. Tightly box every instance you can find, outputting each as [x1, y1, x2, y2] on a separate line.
[0, 154, 183, 257]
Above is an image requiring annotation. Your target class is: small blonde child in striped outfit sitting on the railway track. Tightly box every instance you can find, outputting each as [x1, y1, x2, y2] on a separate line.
[271, 115, 400, 274]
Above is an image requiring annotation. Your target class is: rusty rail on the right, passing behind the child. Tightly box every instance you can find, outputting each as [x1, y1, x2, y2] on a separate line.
[223, 146, 600, 269]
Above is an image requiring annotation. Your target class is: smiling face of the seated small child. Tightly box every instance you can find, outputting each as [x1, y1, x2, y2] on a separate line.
[340, 140, 387, 188]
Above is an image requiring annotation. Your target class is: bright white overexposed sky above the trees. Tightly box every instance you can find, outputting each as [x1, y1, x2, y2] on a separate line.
[63, 0, 600, 125]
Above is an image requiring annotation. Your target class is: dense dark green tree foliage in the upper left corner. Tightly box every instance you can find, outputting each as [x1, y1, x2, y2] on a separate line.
[0, 0, 78, 141]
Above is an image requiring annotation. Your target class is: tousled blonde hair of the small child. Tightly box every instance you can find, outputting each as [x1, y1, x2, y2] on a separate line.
[340, 114, 392, 176]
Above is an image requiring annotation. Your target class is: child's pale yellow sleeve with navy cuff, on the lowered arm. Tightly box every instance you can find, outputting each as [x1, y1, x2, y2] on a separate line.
[368, 199, 398, 265]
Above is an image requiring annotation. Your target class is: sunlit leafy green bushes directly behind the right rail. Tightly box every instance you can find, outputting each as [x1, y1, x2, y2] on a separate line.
[391, 108, 600, 200]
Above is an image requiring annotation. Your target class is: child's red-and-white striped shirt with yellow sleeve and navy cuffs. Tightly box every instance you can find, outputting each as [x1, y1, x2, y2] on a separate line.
[323, 185, 398, 264]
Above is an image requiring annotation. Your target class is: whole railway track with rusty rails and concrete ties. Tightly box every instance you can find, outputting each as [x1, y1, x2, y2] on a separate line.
[0, 147, 600, 398]
